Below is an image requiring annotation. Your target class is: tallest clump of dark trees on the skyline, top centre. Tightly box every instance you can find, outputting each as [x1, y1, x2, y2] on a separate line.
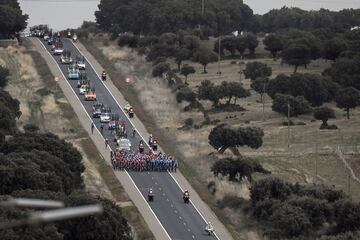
[95, 0, 253, 36]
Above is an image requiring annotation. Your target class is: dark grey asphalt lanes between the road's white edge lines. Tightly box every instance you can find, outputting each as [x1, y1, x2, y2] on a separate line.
[40, 39, 217, 240]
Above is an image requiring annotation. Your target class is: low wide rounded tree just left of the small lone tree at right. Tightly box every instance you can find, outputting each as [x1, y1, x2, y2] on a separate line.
[272, 94, 312, 117]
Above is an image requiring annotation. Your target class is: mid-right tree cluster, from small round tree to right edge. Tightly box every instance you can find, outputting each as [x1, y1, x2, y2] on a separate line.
[244, 60, 360, 120]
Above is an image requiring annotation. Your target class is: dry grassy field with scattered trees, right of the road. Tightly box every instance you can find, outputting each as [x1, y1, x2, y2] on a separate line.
[83, 34, 360, 239]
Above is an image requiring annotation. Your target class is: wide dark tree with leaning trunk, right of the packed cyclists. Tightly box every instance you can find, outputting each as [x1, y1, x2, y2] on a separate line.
[208, 124, 264, 153]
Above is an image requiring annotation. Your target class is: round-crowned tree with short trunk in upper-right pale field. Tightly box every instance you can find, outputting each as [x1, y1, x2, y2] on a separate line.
[282, 44, 310, 73]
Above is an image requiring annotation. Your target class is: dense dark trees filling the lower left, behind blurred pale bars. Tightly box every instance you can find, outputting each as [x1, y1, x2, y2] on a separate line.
[0, 64, 132, 240]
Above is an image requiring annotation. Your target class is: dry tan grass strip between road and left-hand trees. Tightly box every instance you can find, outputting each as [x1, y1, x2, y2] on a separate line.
[0, 41, 154, 239]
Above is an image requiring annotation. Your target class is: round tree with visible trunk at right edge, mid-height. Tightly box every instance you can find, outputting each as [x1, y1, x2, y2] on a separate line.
[335, 87, 360, 119]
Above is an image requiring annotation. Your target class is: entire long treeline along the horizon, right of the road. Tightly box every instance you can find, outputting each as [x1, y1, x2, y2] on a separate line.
[95, 0, 360, 36]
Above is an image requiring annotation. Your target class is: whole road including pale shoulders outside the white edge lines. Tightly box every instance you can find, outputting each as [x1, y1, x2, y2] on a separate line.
[32, 39, 231, 240]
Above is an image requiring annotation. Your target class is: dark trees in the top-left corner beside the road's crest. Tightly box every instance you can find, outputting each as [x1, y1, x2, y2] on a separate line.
[0, 0, 28, 39]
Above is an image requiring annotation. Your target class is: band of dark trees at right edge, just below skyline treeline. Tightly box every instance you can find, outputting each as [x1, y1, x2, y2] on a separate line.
[263, 29, 360, 72]
